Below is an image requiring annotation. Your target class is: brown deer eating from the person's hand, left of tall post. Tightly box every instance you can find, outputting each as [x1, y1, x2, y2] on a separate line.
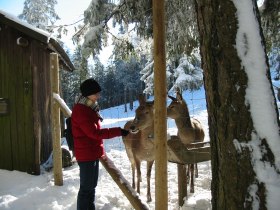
[123, 95, 155, 202]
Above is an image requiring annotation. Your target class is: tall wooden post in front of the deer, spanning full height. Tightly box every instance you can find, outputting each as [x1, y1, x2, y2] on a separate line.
[153, 0, 168, 210]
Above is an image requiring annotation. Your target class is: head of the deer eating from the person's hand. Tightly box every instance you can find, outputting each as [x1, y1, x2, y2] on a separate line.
[130, 94, 154, 133]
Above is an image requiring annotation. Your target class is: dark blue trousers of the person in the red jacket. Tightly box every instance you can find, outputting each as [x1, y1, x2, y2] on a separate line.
[77, 160, 99, 210]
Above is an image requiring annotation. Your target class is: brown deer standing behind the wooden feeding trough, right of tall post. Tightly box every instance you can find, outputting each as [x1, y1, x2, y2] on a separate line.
[167, 89, 205, 193]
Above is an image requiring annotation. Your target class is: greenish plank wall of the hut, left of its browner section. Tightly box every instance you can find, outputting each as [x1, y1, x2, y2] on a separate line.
[0, 24, 36, 174]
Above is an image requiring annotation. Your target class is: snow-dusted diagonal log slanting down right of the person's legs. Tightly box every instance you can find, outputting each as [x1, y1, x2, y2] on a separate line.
[99, 155, 149, 210]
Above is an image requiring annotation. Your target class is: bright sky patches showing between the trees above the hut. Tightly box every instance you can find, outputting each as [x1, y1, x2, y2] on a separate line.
[0, 0, 113, 64]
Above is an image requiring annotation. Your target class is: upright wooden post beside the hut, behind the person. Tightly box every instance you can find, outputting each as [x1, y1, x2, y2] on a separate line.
[50, 53, 63, 186]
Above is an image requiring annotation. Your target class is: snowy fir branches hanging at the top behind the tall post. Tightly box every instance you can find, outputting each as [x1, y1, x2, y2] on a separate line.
[72, 0, 202, 94]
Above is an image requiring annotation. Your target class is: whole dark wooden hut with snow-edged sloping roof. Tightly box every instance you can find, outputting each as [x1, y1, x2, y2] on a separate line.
[0, 10, 74, 175]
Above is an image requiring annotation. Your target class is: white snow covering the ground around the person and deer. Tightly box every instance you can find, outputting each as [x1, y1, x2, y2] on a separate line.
[0, 89, 211, 210]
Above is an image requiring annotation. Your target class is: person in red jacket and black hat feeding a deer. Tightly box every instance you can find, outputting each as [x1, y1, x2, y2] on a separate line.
[72, 78, 129, 210]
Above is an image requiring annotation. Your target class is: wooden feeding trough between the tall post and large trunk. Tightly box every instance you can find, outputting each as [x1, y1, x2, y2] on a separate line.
[167, 136, 211, 165]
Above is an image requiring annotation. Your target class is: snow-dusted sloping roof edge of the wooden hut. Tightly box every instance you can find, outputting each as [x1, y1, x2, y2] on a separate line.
[0, 9, 75, 71]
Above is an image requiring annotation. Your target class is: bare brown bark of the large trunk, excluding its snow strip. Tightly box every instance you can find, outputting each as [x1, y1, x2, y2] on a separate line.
[195, 0, 279, 210]
